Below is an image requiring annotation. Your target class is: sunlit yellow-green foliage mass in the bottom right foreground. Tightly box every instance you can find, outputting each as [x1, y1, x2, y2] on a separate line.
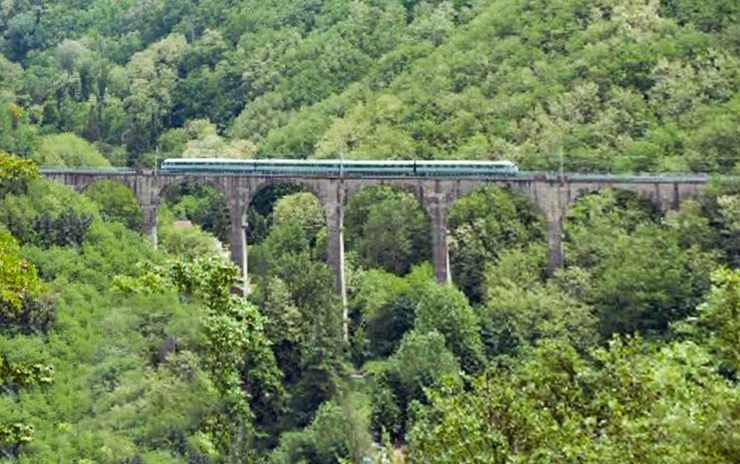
[409, 338, 740, 463]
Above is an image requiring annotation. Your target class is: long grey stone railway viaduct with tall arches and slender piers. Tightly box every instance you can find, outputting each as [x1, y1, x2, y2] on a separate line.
[42, 169, 709, 302]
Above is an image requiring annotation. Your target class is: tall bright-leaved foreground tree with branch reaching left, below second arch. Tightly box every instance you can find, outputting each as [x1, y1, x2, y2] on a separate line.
[121, 258, 284, 460]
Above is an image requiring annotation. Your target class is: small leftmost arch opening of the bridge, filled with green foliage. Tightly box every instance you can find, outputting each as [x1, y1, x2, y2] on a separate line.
[81, 179, 144, 232]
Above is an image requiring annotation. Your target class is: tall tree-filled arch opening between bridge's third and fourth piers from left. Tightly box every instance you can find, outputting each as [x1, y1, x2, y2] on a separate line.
[344, 185, 434, 366]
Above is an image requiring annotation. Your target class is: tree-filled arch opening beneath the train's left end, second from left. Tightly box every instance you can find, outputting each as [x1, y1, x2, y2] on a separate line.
[157, 180, 231, 258]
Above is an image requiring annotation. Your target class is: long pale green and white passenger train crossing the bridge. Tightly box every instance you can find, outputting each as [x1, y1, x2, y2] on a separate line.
[159, 158, 519, 177]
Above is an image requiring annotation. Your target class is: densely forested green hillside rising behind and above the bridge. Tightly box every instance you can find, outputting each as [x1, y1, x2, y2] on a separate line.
[0, 0, 740, 173]
